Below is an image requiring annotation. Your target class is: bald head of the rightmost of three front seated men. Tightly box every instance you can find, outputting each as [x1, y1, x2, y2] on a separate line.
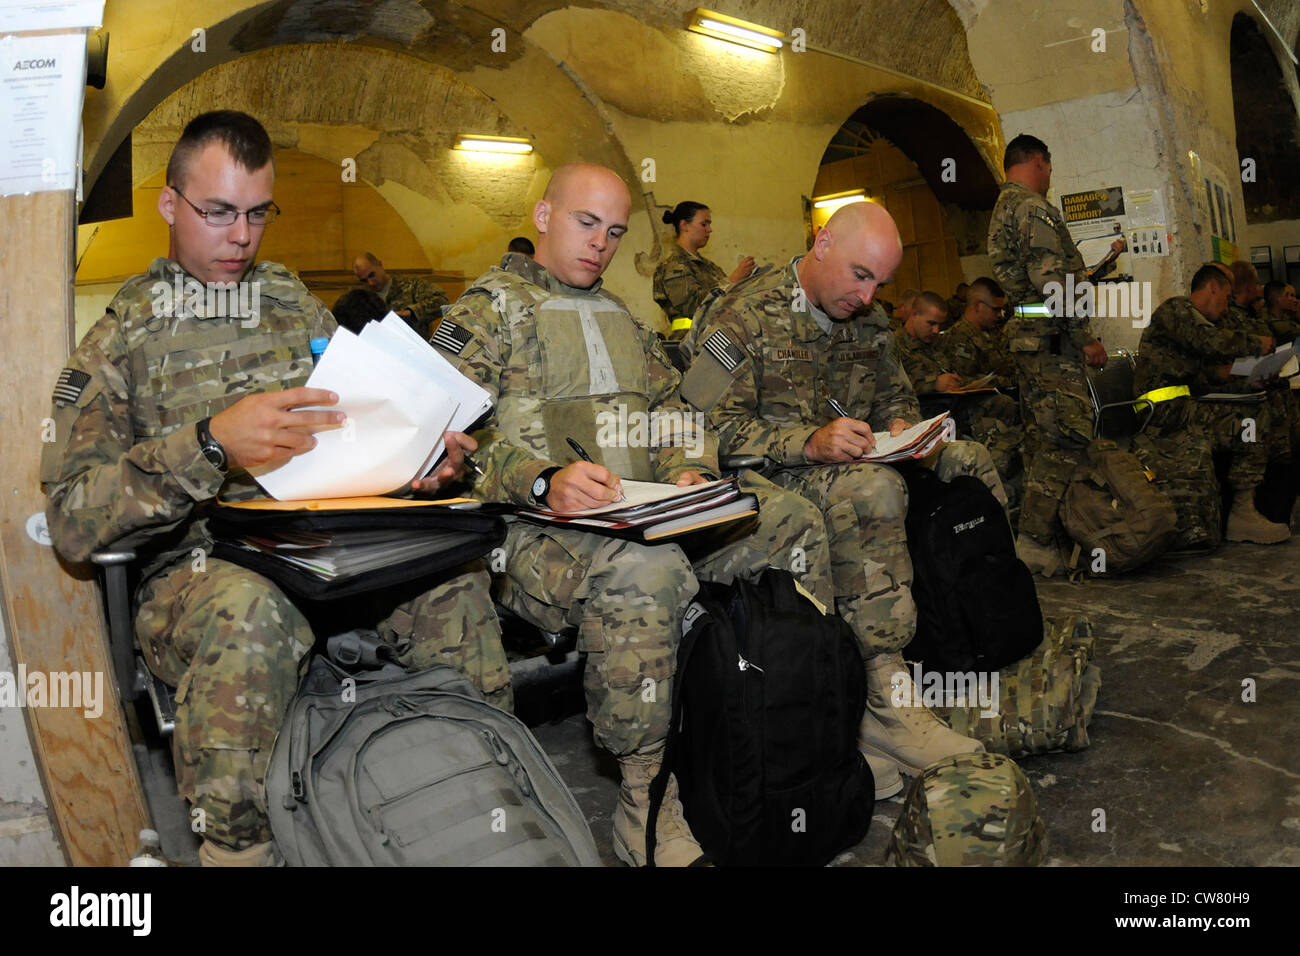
[798, 203, 902, 321]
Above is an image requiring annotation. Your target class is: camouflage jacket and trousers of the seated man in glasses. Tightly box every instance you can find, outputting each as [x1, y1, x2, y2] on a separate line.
[40, 259, 510, 849]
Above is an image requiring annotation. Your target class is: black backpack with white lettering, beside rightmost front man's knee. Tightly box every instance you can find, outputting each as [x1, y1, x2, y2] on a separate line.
[902, 467, 1043, 672]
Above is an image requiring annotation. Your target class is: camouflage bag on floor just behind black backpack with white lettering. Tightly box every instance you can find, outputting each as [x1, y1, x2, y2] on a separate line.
[933, 615, 1101, 757]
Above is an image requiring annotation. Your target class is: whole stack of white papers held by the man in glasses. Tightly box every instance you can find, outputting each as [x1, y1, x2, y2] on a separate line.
[252, 312, 491, 501]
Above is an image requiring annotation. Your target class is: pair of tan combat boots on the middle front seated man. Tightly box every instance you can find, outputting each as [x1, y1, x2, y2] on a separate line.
[614, 744, 705, 866]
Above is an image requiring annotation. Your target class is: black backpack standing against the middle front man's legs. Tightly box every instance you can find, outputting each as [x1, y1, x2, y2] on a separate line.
[646, 568, 875, 866]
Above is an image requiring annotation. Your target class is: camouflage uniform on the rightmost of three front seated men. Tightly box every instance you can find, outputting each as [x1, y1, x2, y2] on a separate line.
[681, 259, 1006, 658]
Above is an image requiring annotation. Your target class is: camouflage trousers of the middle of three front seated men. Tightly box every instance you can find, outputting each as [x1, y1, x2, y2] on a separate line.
[499, 472, 831, 757]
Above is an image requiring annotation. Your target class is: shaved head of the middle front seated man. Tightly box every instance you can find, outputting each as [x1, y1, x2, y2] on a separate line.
[533, 163, 632, 289]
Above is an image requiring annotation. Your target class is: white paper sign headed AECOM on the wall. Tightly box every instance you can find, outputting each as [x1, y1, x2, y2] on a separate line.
[0, 33, 86, 196]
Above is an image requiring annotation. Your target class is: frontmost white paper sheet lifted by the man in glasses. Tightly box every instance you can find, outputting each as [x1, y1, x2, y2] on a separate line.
[254, 328, 458, 501]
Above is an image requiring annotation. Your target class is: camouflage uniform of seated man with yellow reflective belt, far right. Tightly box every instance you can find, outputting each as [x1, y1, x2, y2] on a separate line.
[1134, 295, 1271, 494]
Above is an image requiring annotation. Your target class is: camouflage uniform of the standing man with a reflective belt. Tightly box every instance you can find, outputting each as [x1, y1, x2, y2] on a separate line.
[988, 182, 1093, 544]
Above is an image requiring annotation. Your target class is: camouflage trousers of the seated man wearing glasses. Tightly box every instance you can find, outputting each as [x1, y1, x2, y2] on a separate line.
[135, 558, 511, 849]
